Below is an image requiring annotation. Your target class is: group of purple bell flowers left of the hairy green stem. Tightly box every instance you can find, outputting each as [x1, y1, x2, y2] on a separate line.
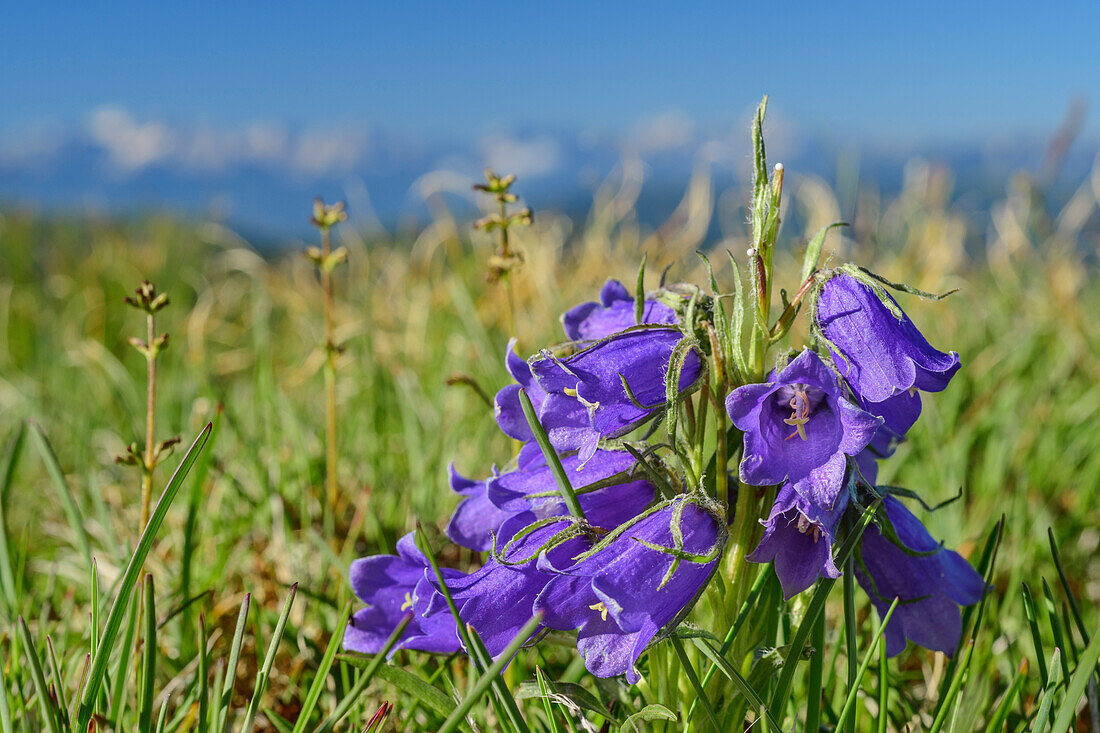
[344, 281, 727, 682]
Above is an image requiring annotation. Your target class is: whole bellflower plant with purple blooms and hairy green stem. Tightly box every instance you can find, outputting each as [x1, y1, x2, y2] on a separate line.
[344, 96, 985, 730]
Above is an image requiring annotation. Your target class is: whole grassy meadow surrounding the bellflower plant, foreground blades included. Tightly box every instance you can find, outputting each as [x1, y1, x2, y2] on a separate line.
[0, 128, 1100, 733]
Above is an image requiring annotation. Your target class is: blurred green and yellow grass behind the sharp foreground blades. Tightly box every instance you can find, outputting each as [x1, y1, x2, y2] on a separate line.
[0, 132, 1100, 730]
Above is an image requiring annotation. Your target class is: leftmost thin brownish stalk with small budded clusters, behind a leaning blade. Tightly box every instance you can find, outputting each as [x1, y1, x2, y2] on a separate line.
[114, 281, 179, 532]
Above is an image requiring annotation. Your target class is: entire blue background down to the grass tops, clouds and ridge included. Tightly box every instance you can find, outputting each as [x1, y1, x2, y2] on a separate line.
[0, 0, 1100, 232]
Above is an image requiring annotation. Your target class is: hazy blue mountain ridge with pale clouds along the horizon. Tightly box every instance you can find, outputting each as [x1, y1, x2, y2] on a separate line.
[0, 108, 1097, 239]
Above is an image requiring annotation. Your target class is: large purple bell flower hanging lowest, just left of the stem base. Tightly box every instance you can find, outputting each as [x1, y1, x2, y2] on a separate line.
[535, 494, 726, 683]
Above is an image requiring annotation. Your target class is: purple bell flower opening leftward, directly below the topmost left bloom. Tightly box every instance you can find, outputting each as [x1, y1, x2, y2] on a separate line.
[529, 326, 703, 462]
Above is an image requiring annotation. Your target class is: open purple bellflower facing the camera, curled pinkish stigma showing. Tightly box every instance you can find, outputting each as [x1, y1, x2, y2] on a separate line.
[726, 349, 882, 506]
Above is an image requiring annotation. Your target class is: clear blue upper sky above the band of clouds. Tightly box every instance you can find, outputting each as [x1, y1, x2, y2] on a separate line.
[0, 1, 1100, 139]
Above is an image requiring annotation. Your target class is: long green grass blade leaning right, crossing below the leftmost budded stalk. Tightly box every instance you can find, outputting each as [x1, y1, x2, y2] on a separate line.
[75, 423, 210, 731]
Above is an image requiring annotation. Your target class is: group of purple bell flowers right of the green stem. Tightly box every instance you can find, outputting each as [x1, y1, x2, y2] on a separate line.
[727, 265, 985, 655]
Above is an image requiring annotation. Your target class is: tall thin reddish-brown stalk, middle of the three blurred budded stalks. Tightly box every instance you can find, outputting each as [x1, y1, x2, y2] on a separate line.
[306, 198, 348, 517]
